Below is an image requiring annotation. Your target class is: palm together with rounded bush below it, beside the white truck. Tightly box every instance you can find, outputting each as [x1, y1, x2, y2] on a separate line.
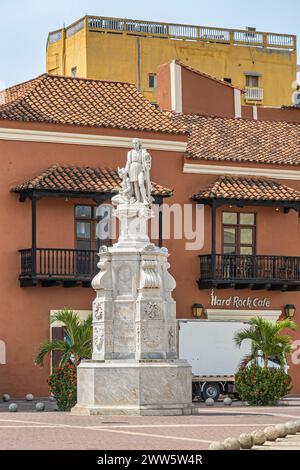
[234, 317, 297, 405]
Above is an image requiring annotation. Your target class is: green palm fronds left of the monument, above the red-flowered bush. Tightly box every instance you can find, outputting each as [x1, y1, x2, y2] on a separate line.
[35, 308, 93, 367]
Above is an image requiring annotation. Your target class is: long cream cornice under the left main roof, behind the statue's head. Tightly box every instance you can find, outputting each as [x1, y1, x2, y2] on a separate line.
[0, 127, 187, 152]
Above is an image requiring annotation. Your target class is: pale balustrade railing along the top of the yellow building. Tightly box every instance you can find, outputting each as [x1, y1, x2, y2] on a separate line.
[48, 16, 296, 50]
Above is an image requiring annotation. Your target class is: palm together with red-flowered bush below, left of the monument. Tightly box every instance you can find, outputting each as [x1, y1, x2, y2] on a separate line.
[35, 308, 93, 411]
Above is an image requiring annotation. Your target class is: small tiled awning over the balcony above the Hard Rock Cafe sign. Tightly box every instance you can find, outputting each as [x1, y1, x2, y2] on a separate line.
[193, 175, 300, 202]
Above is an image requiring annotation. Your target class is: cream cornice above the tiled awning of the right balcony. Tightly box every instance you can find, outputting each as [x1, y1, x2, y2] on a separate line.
[183, 163, 300, 181]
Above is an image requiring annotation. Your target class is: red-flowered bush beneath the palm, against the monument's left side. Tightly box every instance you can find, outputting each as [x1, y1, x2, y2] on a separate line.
[48, 363, 77, 411]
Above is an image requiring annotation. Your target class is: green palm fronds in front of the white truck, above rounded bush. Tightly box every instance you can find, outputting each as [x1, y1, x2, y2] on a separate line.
[234, 317, 297, 369]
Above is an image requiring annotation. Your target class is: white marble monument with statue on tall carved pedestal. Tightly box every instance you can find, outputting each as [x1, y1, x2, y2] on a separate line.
[72, 139, 192, 415]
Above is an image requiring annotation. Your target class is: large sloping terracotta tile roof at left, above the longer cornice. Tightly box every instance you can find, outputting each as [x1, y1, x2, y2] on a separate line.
[0, 74, 186, 134]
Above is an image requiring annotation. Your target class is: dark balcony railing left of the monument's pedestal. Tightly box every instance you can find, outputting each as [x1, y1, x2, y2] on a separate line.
[19, 248, 98, 287]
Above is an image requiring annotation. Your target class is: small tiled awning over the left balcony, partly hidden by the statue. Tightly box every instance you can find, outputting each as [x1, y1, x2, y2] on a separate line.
[12, 165, 173, 197]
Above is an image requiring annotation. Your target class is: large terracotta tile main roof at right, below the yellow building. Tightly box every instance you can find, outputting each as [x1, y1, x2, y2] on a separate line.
[173, 114, 300, 166]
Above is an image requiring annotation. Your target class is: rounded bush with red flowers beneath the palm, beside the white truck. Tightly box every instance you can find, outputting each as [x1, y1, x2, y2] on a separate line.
[235, 364, 291, 405]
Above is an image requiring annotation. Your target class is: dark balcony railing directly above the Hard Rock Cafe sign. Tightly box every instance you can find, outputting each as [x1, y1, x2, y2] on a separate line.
[197, 254, 300, 291]
